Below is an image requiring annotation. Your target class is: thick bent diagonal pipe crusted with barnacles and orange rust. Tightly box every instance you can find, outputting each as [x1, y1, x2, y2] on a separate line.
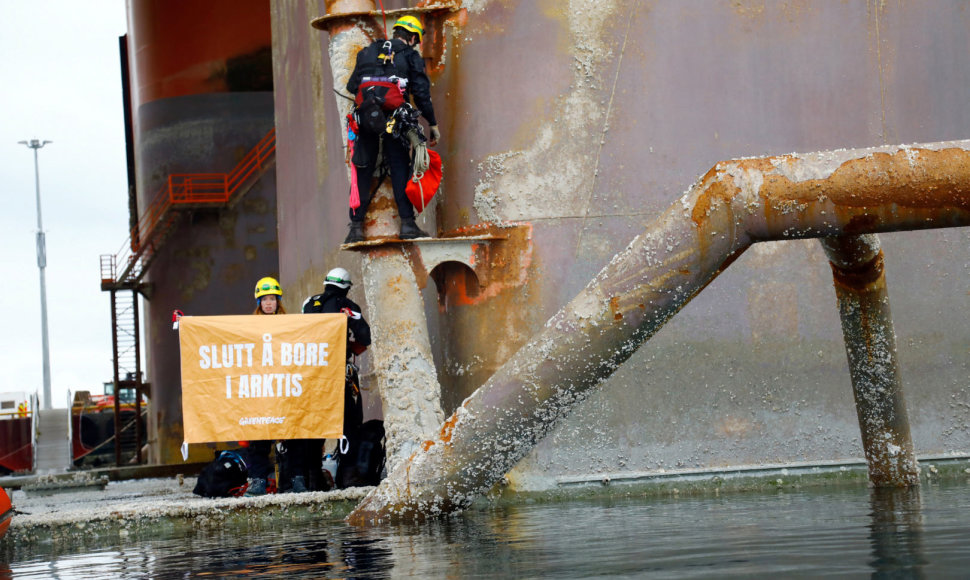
[348, 141, 970, 523]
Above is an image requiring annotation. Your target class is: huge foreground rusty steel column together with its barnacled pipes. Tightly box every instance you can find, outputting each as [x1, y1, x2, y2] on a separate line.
[260, 0, 970, 522]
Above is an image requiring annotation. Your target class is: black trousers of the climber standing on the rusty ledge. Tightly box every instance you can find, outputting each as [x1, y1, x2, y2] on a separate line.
[350, 133, 414, 222]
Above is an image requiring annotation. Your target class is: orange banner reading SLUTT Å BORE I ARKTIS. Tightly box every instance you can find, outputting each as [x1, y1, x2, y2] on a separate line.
[179, 314, 347, 443]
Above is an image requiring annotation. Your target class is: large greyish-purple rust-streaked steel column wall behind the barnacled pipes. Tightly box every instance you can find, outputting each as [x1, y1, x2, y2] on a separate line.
[271, 0, 970, 516]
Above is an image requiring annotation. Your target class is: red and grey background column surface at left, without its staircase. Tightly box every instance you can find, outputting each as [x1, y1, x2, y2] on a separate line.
[127, 0, 278, 464]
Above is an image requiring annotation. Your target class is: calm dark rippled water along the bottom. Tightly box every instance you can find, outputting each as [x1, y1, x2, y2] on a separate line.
[0, 483, 970, 579]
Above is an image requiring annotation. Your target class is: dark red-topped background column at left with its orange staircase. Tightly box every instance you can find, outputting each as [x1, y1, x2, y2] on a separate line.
[113, 0, 279, 464]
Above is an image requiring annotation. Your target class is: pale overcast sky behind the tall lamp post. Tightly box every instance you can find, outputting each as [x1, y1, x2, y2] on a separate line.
[0, 0, 128, 408]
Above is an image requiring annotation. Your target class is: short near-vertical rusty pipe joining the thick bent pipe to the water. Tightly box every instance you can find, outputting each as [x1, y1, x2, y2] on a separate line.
[821, 235, 919, 487]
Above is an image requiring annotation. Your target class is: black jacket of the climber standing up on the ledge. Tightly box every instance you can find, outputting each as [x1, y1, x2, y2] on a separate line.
[347, 38, 438, 125]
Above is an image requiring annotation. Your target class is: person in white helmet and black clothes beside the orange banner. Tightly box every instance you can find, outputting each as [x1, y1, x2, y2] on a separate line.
[303, 268, 371, 484]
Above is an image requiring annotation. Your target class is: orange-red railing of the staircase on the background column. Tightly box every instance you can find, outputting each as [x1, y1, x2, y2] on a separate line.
[101, 128, 276, 287]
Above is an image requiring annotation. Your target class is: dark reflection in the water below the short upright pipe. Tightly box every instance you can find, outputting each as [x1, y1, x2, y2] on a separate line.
[869, 488, 927, 579]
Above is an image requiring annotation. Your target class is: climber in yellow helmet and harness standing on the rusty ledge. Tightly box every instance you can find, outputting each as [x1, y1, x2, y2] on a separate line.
[344, 16, 441, 244]
